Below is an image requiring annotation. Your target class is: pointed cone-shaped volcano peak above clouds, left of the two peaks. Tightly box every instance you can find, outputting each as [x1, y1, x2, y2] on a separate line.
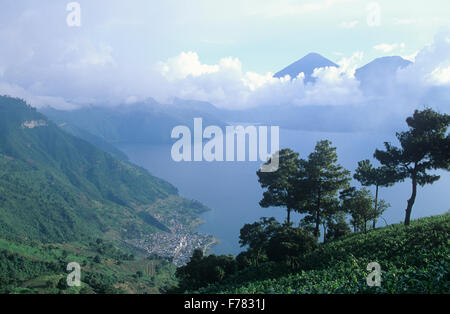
[274, 53, 339, 83]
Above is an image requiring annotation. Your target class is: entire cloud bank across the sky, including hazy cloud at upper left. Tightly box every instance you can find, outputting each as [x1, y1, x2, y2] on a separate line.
[0, 1, 450, 112]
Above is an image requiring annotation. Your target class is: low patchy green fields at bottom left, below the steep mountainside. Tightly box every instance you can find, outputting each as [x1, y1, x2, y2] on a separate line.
[0, 239, 176, 294]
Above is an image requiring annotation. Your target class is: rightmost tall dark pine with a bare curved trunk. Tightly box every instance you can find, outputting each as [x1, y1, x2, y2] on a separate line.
[374, 109, 450, 225]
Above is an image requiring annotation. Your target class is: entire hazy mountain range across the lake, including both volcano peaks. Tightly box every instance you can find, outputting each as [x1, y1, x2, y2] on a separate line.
[40, 53, 411, 144]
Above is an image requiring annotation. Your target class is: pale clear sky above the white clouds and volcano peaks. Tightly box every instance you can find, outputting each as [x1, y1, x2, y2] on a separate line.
[80, 0, 450, 72]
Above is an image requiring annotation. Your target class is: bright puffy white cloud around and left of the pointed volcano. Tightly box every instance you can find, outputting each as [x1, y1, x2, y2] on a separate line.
[157, 52, 363, 109]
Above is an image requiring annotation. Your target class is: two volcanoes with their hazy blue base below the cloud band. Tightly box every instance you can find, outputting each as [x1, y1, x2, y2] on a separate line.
[229, 53, 411, 132]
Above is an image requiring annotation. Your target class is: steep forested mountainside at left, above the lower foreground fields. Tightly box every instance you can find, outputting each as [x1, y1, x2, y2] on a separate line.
[0, 96, 205, 243]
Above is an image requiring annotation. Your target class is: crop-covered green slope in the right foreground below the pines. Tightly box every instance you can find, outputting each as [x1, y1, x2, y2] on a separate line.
[194, 214, 450, 294]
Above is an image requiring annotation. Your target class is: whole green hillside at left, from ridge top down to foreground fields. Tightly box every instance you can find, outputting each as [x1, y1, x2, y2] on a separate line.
[0, 97, 216, 293]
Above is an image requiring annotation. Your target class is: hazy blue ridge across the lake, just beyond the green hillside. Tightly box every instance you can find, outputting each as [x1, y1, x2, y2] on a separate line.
[40, 99, 223, 144]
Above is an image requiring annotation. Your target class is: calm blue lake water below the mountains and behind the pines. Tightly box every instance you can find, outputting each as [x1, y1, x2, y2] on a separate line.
[119, 129, 450, 254]
